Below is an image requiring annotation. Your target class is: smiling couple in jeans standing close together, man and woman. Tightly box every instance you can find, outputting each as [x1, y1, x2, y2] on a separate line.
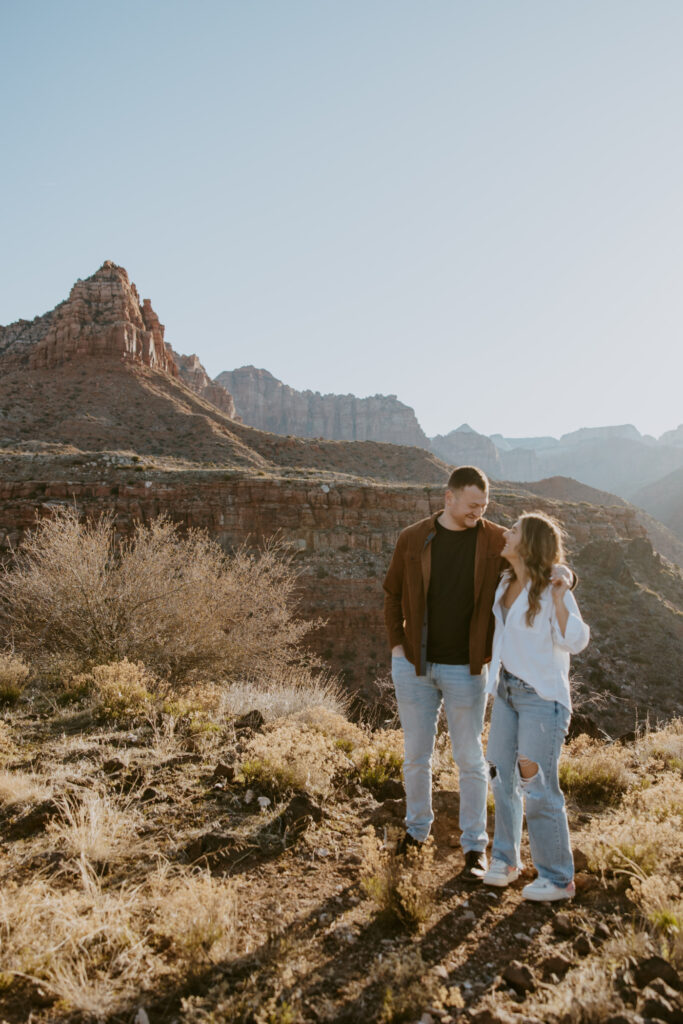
[384, 466, 589, 901]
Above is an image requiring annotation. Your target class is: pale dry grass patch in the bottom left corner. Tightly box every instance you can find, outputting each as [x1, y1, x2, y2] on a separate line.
[0, 863, 241, 1020]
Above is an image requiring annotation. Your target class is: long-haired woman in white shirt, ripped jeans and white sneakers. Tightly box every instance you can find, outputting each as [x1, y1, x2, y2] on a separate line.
[483, 512, 590, 901]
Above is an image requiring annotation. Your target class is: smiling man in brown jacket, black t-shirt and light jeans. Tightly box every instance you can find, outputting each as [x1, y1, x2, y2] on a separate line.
[384, 466, 505, 882]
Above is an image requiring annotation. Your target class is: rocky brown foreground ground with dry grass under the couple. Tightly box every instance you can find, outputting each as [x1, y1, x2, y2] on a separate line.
[0, 694, 683, 1024]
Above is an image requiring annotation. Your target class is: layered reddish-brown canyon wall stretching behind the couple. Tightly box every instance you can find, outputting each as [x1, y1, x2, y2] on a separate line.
[0, 468, 683, 732]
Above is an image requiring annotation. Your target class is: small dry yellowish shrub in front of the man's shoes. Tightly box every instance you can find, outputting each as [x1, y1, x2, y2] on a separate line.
[360, 829, 434, 928]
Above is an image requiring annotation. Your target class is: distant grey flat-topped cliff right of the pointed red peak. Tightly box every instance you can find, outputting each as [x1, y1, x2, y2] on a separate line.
[216, 367, 429, 449]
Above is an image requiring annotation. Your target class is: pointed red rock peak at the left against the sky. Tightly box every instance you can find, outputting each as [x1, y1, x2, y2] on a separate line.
[0, 260, 178, 377]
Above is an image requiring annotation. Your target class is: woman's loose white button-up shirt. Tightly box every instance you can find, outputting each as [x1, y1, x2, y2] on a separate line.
[486, 572, 591, 711]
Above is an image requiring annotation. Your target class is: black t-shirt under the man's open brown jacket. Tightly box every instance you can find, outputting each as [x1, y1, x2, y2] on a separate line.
[427, 522, 478, 665]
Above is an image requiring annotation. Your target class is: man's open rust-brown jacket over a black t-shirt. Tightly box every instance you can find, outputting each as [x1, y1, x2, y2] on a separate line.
[384, 510, 507, 676]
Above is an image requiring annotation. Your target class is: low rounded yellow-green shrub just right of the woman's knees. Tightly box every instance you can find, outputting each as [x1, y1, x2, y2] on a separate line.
[559, 735, 635, 806]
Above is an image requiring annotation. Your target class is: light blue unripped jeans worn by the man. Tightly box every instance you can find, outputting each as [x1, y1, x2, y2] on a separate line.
[391, 656, 488, 853]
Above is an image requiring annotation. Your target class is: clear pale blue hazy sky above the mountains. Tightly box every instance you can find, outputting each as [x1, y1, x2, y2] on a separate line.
[0, 0, 683, 436]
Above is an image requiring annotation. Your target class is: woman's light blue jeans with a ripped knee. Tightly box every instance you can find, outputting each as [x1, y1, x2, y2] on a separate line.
[486, 669, 573, 886]
